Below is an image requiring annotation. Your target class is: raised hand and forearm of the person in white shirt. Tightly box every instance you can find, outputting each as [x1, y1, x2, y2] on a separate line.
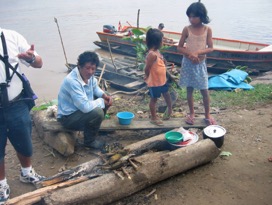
[18, 45, 43, 68]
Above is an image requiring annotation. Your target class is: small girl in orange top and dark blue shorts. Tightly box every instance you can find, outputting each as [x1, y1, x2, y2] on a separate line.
[145, 28, 172, 126]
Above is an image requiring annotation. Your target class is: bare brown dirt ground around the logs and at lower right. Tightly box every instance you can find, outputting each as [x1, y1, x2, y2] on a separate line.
[3, 73, 272, 205]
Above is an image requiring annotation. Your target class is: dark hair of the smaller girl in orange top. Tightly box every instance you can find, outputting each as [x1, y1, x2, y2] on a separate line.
[146, 28, 163, 50]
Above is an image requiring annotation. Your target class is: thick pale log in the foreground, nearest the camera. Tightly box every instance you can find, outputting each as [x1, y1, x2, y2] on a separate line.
[44, 139, 220, 205]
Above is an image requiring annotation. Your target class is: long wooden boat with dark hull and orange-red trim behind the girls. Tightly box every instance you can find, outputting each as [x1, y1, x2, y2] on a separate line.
[94, 27, 272, 72]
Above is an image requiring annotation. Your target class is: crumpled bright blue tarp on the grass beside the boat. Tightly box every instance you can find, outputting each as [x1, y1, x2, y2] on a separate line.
[208, 69, 254, 90]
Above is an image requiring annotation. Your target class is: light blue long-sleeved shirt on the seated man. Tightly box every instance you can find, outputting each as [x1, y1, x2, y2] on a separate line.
[57, 67, 105, 118]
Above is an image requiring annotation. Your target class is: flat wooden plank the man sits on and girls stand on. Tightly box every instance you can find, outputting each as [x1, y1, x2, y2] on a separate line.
[42, 118, 207, 132]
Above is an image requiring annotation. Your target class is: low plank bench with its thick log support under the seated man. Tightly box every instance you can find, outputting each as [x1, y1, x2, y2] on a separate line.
[32, 111, 206, 156]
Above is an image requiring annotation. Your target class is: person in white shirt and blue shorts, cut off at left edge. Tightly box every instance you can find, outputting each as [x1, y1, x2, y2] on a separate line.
[0, 28, 44, 204]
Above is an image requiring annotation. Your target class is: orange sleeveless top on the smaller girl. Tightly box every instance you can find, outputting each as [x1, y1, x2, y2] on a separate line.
[145, 51, 166, 87]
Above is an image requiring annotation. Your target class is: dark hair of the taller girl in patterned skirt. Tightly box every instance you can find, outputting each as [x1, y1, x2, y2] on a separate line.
[186, 2, 210, 24]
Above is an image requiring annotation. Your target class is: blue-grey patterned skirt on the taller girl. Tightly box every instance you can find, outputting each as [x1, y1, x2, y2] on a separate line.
[179, 56, 208, 90]
